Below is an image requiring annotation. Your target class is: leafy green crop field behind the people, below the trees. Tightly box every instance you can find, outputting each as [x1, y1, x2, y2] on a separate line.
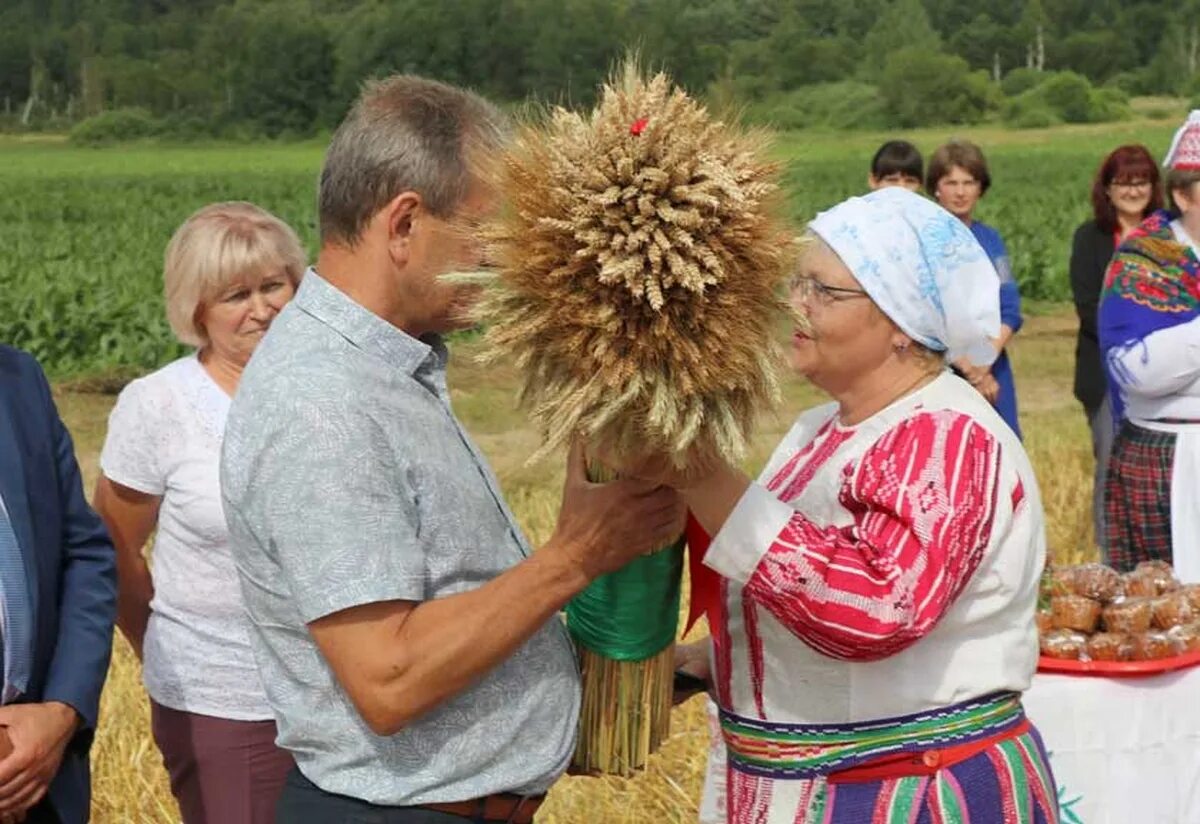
[0, 121, 1172, 378]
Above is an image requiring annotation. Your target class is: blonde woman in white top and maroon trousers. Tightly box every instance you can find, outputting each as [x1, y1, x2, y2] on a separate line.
[95, 203, 305, 824]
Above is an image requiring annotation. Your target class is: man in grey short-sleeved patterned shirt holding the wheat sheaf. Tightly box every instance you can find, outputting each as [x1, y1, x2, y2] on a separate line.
[221, 77, 682, 824]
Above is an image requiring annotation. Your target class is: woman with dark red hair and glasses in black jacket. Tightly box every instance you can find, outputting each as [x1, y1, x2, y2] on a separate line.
[1070, 144, 1162, 551]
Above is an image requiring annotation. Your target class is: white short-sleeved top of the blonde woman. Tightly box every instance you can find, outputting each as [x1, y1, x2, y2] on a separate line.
[100, 355, 271, 721]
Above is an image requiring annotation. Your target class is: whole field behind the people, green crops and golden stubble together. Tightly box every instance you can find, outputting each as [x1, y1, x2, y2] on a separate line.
[9, 122, 1170, 824]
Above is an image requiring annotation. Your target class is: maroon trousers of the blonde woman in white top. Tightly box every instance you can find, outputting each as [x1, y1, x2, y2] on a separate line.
[150, 700, 295, 824]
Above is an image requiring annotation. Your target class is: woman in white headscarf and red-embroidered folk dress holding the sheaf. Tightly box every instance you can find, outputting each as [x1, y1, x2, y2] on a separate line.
[672, 188, 1057, 824]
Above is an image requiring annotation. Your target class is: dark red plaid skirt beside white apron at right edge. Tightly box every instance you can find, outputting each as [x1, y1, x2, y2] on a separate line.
[1104, 421, 1175, 572]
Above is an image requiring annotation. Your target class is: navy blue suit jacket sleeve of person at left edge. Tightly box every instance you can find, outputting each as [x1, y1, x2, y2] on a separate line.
[34, 359, 116, 729]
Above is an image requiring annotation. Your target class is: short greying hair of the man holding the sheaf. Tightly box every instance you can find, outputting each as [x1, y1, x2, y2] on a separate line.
[317, 74, 505, 245]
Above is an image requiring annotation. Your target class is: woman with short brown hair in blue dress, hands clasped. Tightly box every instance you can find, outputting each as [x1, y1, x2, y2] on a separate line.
[925, 140, 1024, 438]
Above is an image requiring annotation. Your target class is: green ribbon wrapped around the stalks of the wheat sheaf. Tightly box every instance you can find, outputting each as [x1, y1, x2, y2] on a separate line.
[566, 537, 684, 661]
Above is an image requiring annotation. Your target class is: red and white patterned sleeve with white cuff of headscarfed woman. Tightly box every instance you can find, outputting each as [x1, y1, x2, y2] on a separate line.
[704, 410, 1024, 661]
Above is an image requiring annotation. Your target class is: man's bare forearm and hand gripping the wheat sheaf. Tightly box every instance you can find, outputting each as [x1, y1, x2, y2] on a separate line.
[308, 444, 684, 735]
